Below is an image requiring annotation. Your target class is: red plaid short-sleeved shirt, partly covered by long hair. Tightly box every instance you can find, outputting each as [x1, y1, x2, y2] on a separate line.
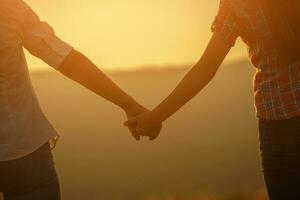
[212, 0, 300, 120]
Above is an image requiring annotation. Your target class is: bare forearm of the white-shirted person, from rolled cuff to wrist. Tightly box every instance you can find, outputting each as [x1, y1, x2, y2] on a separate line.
[59, 50, 136, 110]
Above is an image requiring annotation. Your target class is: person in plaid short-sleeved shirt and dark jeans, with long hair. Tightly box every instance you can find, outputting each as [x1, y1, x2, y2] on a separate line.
[124, 0, 300, 200]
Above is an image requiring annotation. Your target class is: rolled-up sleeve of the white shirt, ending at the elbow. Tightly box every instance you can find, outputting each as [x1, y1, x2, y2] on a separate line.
[18, 1, 73, 70]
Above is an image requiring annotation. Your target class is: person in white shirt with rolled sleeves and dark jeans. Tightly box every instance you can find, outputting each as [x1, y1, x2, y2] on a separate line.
[0, 0, 159, 200]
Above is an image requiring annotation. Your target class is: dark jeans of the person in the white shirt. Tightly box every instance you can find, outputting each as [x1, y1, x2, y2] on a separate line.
[0, 144, 60, 200]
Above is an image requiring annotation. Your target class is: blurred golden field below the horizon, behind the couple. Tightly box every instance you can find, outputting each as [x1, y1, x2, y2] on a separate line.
[0, 61, 265, 200]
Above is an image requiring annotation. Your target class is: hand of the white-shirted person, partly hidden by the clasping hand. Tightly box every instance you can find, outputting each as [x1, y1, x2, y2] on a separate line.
[124, 103, 149, 141]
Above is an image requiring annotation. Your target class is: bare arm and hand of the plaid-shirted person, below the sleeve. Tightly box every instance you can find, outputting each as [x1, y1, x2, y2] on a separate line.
[125, 34, 231, 134]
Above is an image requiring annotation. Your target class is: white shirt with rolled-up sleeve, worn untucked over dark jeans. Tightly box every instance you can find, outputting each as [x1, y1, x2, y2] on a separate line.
[0, 0, 72, 161]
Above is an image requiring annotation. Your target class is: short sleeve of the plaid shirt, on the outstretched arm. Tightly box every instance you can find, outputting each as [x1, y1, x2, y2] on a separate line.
[211, 0, 240, 46]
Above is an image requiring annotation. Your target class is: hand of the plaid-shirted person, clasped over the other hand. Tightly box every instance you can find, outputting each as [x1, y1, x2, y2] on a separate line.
[124, 111, 162, 140]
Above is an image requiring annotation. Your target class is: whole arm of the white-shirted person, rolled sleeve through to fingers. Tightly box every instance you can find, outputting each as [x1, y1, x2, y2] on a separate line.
[16, 1, 148, 139]
